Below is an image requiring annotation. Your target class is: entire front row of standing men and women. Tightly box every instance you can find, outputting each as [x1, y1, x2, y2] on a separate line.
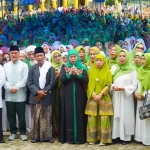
[0, 46, 150, 145]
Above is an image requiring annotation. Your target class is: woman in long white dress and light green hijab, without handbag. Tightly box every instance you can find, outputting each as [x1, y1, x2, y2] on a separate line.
[111, 49, 137, 145]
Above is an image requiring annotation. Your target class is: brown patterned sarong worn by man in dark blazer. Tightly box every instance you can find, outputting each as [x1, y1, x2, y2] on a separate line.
[30, 104, 52, 142]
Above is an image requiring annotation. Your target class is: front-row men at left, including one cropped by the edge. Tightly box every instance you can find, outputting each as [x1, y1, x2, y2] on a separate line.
[0, 46, 55, 143]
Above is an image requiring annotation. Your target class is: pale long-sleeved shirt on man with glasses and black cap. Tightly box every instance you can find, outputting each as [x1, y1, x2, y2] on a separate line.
[4, 60, 28, 102]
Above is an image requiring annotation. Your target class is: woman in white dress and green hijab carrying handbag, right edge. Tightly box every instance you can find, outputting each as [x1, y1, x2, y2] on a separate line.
[134, 53, 150, 146]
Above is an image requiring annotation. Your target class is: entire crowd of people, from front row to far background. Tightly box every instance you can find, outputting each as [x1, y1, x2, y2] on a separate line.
[0, 3, 150, 146]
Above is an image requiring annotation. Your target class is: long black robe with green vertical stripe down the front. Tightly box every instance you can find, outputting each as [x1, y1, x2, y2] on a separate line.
[59, 65, 88, 144]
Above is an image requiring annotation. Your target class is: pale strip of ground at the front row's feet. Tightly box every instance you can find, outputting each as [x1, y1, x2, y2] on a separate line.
[0, 133, 150, 150]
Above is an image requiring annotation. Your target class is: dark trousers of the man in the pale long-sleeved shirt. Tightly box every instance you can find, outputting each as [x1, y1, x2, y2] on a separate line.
[6, 101, 26, 135]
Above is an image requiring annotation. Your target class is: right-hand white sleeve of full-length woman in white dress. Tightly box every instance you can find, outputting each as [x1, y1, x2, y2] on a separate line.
[125, 71, 138, 97]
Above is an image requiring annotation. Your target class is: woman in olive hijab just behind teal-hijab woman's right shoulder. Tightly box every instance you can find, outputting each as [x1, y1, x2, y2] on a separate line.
[75, 46, 87, 64]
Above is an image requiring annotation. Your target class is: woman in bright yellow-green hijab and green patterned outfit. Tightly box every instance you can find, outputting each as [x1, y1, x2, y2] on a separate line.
[85, 54, 113, 145]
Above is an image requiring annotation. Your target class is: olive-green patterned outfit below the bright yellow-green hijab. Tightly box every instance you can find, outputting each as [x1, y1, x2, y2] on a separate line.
[85, 86, 113, 143]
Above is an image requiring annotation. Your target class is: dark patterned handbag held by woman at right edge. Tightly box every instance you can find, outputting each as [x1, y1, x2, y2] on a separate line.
[139, 92, 150, 120]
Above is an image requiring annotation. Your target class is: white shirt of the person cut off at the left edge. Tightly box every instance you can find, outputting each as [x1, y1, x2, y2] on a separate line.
[0, 65, 5, 108]
